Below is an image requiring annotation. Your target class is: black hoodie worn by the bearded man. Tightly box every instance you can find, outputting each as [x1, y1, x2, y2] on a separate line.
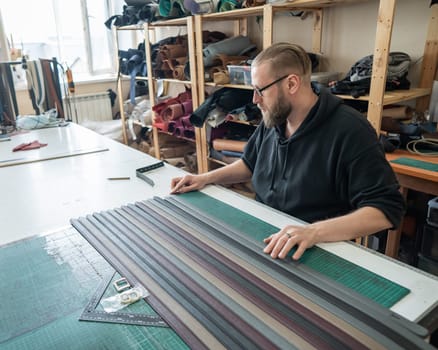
[242, 88, 404, 227]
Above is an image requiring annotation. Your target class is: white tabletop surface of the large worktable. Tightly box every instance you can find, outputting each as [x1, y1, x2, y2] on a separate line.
[0, 123, 438, 321]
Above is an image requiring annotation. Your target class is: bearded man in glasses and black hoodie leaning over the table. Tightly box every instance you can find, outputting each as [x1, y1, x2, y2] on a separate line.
[171, 43, 405, 260]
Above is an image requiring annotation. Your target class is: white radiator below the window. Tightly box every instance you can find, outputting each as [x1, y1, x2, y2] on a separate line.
[64, 92, 113, 124]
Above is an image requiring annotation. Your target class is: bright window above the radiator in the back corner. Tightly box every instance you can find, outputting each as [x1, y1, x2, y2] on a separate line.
[0, 0, 123, 80]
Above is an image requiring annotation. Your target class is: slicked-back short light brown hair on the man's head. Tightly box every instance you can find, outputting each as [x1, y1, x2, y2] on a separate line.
[252, 42, 312, 78]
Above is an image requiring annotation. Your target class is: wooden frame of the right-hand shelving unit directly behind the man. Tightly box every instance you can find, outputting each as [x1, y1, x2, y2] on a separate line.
[195, 0, 438, 171]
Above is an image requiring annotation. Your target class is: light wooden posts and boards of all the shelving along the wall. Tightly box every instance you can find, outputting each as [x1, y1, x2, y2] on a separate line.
[118, 0, 438, 172]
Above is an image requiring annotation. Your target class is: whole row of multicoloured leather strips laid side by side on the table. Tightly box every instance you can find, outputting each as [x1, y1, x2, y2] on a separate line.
[72, 198, 427, 349]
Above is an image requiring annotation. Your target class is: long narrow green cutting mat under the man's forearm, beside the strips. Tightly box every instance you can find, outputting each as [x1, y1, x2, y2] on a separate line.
[179, 192, 409, 308]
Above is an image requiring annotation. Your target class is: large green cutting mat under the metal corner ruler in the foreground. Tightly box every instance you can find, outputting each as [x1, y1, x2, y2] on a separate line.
[0, 229, 188, 350]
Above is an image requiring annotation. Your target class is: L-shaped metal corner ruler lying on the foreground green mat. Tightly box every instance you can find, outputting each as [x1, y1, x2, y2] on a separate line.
[79, 271, 169, 327]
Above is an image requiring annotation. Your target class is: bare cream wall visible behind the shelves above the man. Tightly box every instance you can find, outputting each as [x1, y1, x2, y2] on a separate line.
[255, 0, 430, 86]
